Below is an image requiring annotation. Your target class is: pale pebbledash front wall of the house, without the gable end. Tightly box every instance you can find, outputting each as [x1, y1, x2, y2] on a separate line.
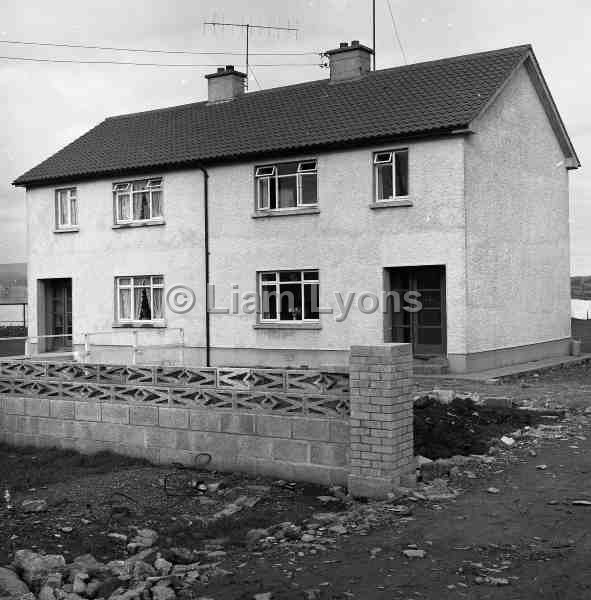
[27, 137, 466, 365]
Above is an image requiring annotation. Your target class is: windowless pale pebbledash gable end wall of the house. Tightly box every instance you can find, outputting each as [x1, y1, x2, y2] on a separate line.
[465, 67, 570, 353]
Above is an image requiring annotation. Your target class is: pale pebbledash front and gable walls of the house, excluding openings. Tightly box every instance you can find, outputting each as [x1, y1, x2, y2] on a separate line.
[27, 61, 570, 372]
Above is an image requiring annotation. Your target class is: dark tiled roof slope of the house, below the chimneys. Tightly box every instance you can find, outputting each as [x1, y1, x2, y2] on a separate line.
[15, 46, 531, 185]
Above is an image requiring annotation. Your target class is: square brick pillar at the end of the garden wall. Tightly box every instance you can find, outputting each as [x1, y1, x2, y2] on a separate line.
[348, 344, 415, 498]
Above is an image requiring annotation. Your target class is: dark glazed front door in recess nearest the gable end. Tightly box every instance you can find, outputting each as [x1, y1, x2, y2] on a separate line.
[385, 266, 446, 356]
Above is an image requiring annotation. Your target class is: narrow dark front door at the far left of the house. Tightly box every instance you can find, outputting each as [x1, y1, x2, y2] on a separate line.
[40, 279, 72, 352]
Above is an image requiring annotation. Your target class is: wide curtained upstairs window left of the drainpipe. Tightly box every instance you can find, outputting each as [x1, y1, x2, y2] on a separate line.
[113, 178, 162, 225]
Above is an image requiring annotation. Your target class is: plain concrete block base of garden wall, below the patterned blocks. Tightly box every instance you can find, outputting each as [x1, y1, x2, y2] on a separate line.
[0, 395, 349, 485]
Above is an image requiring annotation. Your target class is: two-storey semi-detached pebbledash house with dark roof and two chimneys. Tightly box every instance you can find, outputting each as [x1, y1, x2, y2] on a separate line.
[15, 41, 580, 372]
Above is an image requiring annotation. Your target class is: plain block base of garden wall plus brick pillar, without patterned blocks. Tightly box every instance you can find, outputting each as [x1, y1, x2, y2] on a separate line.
[0, 344, 414, 498]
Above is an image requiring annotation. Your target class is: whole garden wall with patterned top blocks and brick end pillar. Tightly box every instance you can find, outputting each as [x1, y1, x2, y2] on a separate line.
[0, 344, 414, 497]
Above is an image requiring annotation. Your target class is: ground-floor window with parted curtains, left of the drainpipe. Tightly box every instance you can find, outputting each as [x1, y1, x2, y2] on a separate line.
[115, 275, 164, 323]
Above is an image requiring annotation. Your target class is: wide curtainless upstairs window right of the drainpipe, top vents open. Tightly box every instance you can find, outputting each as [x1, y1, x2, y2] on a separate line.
[255, 160, 318, 210]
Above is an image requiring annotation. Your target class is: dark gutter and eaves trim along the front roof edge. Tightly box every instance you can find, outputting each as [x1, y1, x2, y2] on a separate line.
[12, 123, 470, 189]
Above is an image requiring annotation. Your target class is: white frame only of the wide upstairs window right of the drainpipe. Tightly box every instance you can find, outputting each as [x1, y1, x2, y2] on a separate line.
[254, 158, 319, 213]
